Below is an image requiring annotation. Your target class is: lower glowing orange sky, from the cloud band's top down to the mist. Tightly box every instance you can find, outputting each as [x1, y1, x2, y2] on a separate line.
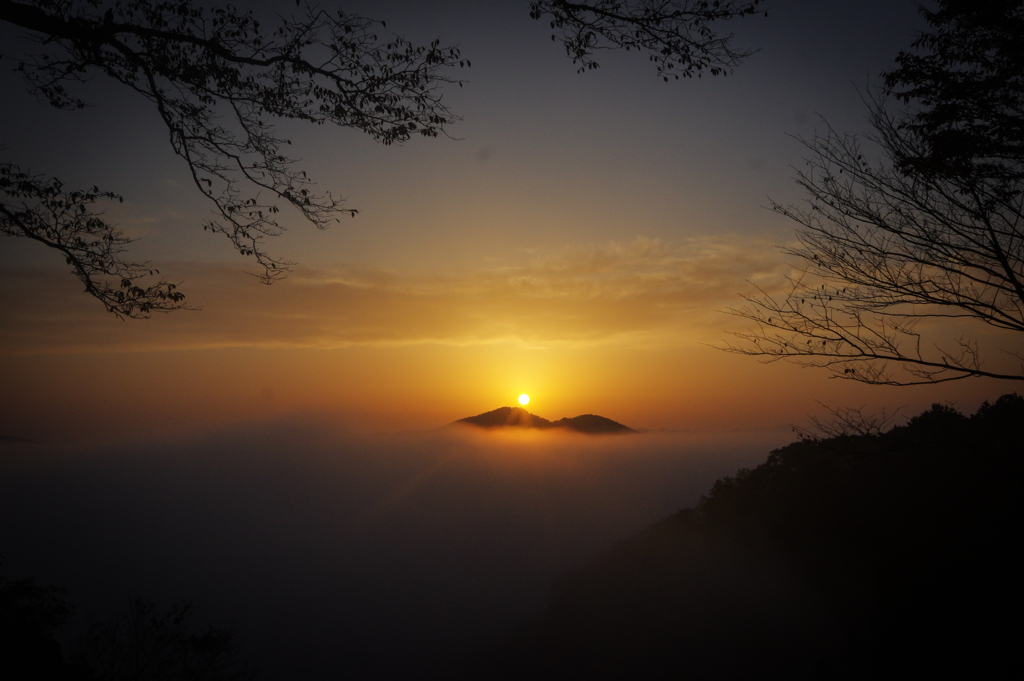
[0, 240, 1009, 439]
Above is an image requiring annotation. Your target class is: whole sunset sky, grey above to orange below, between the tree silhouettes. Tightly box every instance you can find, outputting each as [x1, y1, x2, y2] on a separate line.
[0, 0, 1012, 438]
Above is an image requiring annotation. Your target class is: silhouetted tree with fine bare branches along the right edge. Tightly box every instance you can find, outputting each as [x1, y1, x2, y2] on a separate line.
[727, 0, 1024, 385]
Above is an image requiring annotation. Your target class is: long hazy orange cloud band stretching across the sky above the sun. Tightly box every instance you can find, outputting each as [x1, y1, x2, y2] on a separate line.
[0, 233, 784, 352]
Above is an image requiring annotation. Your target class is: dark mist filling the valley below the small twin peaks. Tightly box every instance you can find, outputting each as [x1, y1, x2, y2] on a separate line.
[0, 417, 788, 679]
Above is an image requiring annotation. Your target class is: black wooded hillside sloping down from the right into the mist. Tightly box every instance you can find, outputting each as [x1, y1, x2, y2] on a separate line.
[468, 395, 1024, 679]
